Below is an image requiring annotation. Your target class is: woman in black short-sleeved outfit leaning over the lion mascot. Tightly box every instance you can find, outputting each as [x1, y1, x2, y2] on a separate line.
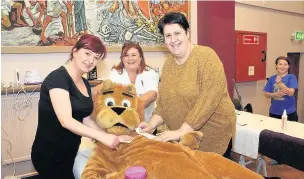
[31, 34, 119, 179]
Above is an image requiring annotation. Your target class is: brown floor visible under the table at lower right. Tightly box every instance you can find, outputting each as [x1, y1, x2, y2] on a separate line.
[231, 152, 304, 179]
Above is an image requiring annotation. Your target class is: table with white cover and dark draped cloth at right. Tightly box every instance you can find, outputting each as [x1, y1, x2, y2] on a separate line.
[232, 111, 304, 176]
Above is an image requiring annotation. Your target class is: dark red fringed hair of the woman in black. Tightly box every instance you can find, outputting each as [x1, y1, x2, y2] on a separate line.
[69, 34, 107, 60]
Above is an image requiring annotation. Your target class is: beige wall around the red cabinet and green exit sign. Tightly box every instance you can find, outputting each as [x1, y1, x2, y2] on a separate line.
[235, 2, 304, 121]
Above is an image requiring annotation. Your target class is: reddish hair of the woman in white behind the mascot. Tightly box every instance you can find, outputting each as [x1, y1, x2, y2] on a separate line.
[112, 42, 150, 74]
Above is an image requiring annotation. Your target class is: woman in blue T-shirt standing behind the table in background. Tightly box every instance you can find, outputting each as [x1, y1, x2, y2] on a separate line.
[264, 56, 298, 122]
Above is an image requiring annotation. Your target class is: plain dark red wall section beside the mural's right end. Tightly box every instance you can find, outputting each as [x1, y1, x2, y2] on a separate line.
[197, 1, 236, 97]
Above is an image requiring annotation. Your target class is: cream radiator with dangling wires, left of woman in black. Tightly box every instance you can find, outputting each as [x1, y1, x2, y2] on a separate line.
[1, 93, 39, 165]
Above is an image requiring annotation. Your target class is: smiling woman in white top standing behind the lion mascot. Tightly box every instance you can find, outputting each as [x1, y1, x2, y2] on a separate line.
[109, 42, 159, 122]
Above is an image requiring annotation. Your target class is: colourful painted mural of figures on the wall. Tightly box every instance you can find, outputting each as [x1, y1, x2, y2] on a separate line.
[1, 0, 190, 51]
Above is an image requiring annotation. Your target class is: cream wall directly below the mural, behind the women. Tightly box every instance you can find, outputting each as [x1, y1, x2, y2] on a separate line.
[1, 52, 166, 83]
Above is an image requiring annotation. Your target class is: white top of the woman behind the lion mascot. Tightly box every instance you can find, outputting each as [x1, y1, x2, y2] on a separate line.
[108, 69, 159, 122]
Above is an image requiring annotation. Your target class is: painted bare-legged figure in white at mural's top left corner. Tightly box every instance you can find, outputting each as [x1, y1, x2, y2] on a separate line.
[1, 0, 26, 28]
